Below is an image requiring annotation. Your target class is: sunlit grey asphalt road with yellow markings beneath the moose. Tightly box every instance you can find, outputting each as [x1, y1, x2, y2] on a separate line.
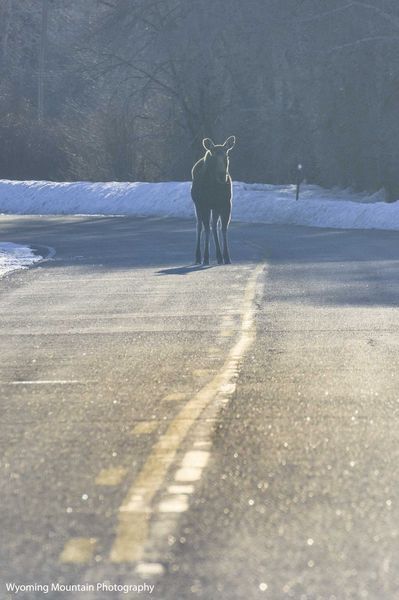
[0, 216, 399, 600]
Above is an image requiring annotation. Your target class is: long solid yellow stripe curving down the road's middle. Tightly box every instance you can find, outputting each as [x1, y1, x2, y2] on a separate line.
[110, 265, 263, 563]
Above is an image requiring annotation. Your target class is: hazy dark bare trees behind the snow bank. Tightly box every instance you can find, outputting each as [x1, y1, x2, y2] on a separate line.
[0, 0, 399, 199]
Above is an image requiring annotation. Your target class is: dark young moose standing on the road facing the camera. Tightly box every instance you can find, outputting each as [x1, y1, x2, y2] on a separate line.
[191, 135, 236, 265]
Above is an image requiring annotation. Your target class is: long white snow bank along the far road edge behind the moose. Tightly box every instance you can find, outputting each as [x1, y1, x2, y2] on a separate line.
[0, 180, 399, 230]
